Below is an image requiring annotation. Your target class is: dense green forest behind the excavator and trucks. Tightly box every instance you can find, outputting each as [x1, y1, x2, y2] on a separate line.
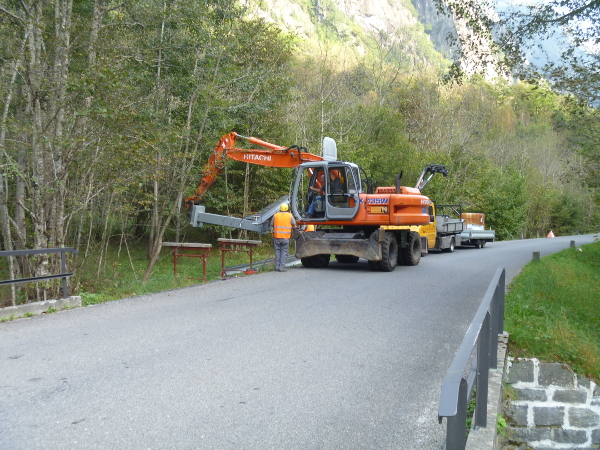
[0, 0, 600, 302]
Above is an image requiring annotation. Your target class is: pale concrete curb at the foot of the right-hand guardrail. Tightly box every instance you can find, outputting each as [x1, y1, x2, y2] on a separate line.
[465, 332, 508, 450]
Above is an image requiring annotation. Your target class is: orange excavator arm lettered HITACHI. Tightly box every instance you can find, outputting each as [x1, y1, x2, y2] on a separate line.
[185, 132, 323, 210]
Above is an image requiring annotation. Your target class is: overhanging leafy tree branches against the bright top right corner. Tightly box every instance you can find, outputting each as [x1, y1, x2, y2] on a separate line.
[436, 0, 600, 104]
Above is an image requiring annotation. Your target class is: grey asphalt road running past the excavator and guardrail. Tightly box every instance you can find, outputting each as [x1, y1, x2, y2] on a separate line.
[0, 235, 594, 450]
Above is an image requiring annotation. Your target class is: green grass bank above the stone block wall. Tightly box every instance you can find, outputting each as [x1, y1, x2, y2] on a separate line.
[504, 242, 600, 383]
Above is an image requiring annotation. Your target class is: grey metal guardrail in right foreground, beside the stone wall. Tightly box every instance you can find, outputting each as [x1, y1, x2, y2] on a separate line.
[438, 267, 505, 450]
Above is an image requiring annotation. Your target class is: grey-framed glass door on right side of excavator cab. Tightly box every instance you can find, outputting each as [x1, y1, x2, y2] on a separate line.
[325, 163, 360, 220]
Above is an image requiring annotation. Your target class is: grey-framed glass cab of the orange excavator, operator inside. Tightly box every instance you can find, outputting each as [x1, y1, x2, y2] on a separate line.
[291, 161, 362, 222]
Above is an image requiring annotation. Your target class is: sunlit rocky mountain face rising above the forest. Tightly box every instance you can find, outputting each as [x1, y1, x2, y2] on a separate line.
[240, 0, 505, 79]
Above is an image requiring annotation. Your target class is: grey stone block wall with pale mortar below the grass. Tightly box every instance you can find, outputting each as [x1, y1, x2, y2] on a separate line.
[504, 359, 600, 450]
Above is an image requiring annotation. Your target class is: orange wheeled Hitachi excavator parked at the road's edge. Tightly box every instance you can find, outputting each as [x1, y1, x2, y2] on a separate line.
[185, 133, 433, 272]
